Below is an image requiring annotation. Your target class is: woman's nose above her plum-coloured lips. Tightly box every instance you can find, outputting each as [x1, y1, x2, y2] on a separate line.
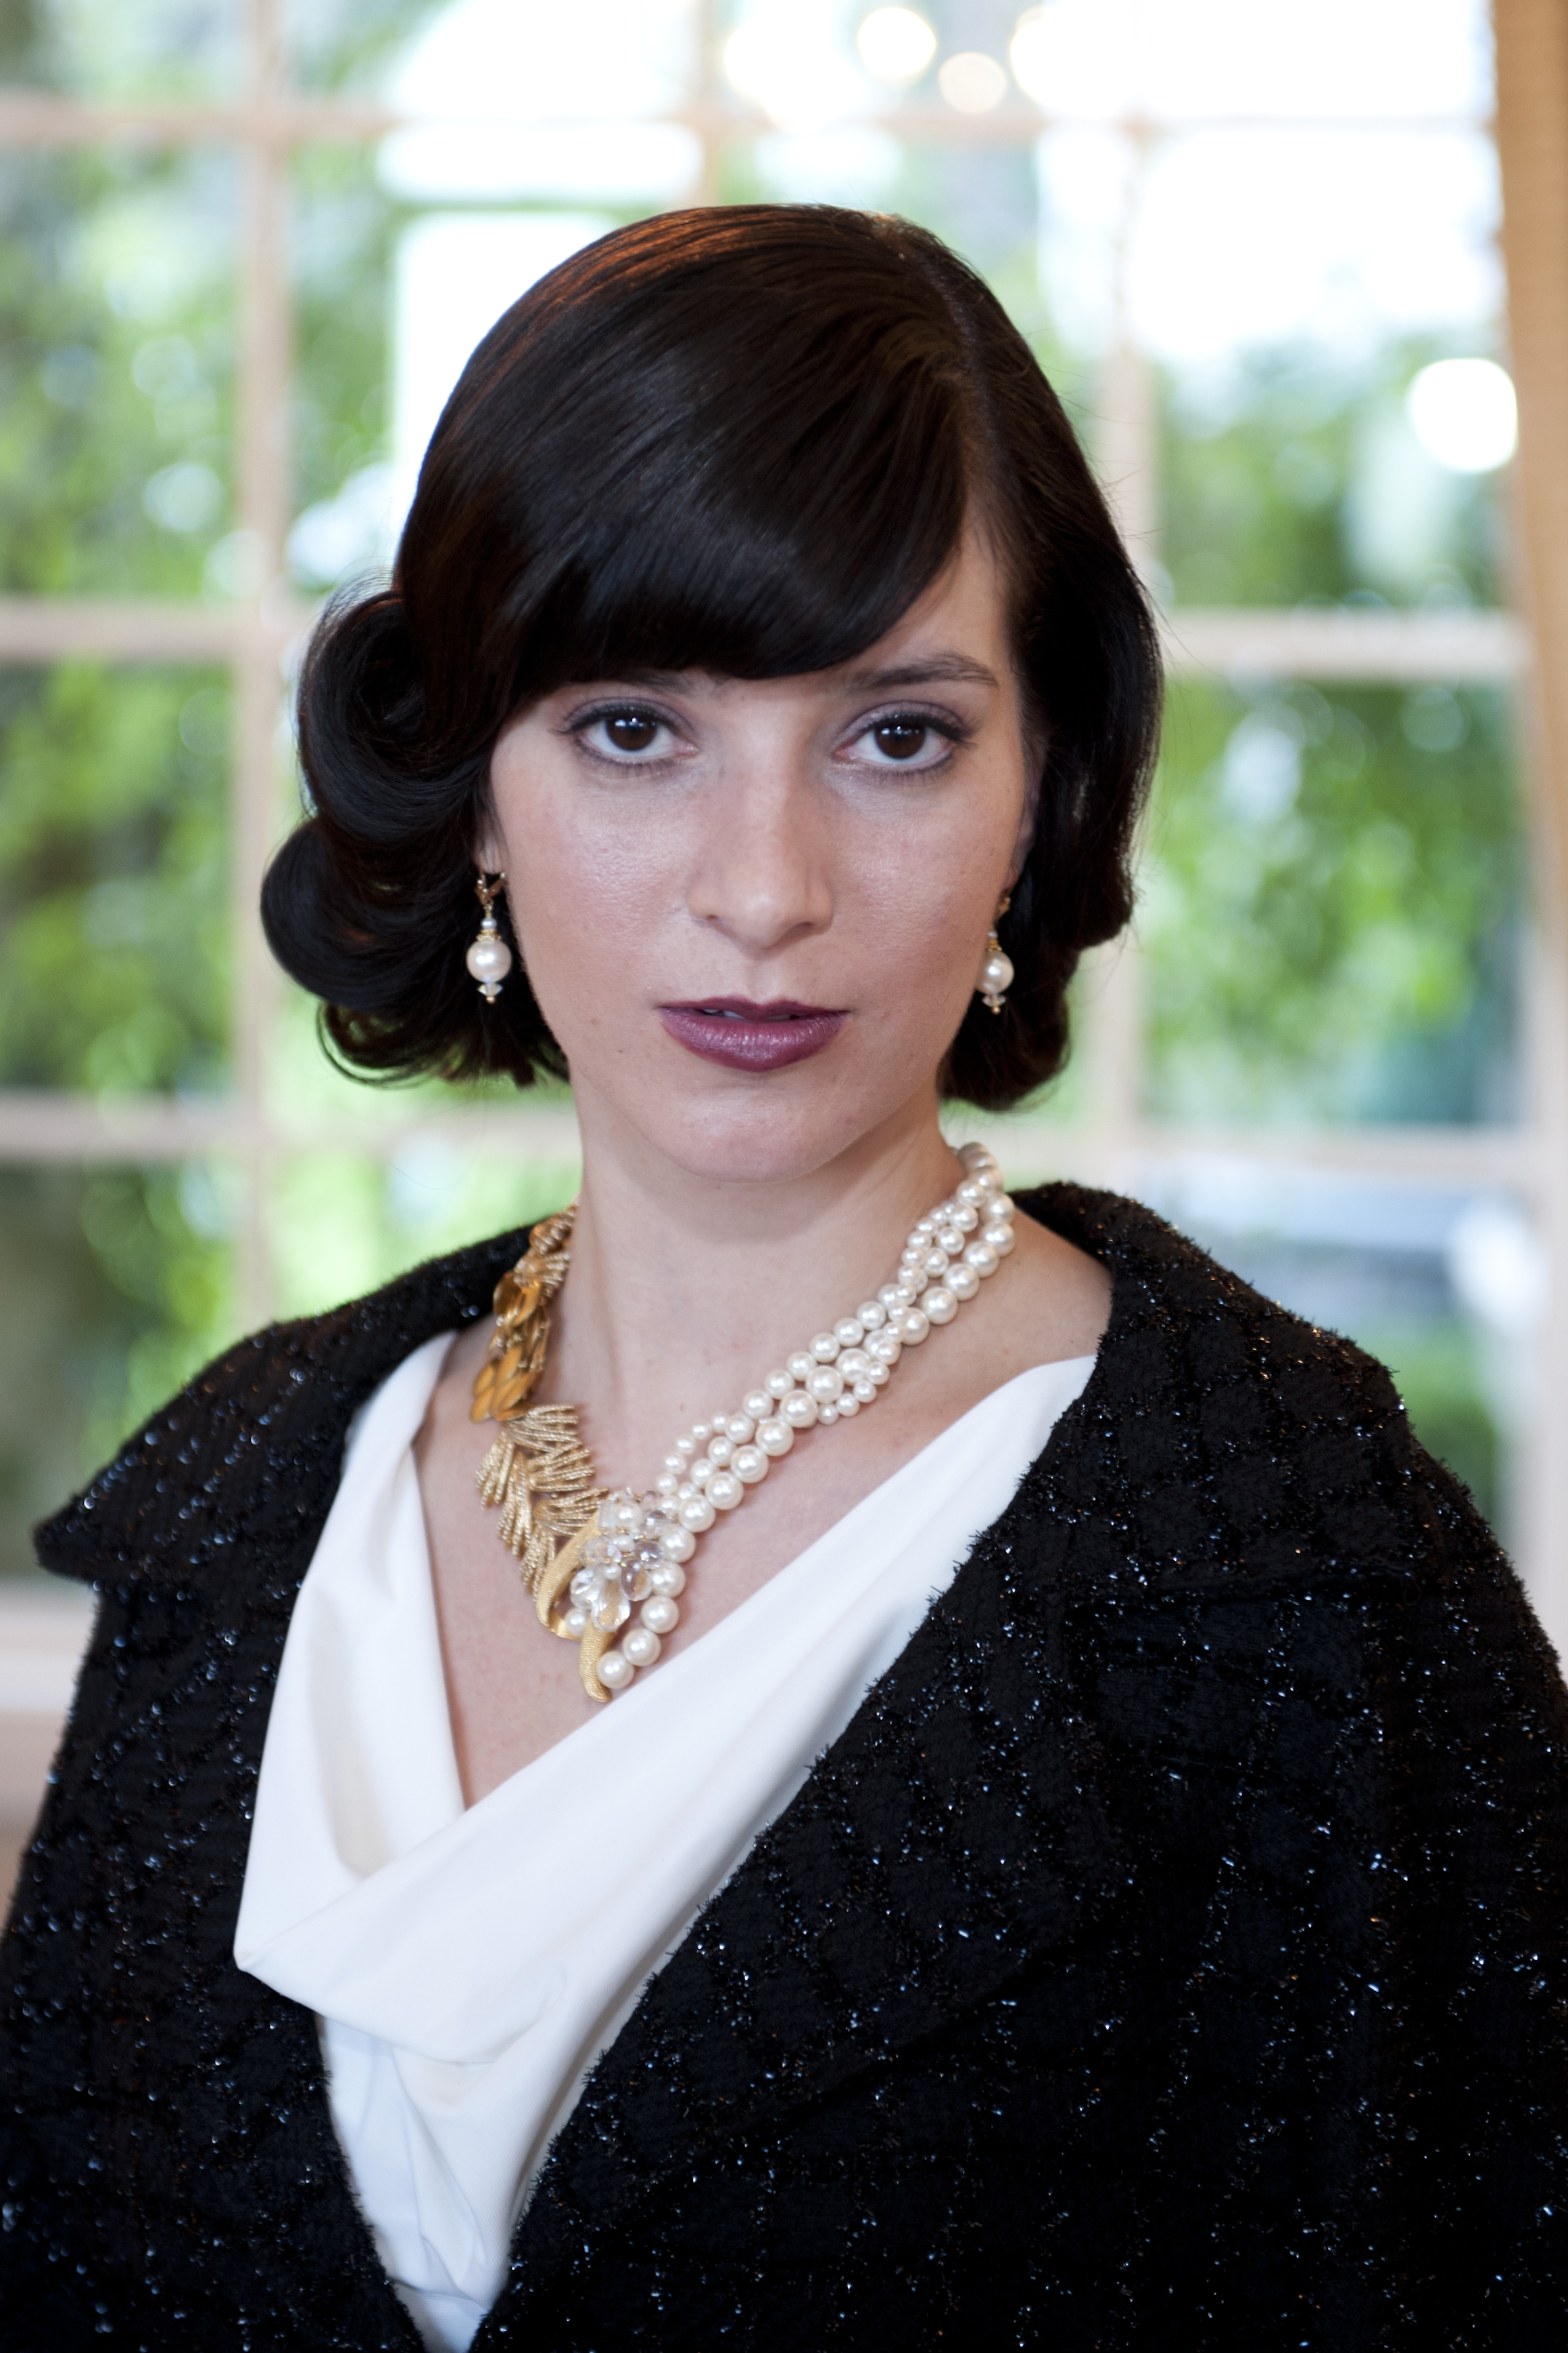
[686, 743, 832, 955]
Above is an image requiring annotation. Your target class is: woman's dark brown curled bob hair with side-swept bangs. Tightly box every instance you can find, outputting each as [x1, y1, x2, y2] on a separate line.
[261, 205, 1159, 1111]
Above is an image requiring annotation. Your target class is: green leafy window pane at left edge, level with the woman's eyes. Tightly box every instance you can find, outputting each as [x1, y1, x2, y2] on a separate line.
[0, 661, 228, 1094]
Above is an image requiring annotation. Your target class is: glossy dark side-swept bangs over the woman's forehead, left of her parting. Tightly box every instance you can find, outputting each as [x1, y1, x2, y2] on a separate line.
[400, 212, 968, 734]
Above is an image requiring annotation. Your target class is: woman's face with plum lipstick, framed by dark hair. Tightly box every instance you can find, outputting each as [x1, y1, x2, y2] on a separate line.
[479, 534, 1030, 1181]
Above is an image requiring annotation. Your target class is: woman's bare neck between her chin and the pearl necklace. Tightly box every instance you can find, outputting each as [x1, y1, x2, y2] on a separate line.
[541, 1092, 961, 1489]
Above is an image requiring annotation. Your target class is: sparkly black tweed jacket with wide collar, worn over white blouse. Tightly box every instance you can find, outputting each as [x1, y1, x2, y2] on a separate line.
[0, 1186, 1568, 2353]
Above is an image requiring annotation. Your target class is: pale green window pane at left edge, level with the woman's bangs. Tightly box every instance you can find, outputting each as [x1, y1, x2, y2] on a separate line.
[0, 148, 235, 595]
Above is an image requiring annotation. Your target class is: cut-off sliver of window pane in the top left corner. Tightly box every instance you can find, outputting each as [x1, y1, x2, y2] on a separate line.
[0, 0, 242, 99]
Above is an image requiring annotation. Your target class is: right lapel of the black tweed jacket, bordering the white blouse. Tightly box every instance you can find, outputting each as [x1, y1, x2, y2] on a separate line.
[475, 1251, 1133, 2353]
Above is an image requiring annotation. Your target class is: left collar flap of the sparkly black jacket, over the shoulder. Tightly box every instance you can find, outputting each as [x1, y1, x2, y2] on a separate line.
[35, 1231, 527, 1583]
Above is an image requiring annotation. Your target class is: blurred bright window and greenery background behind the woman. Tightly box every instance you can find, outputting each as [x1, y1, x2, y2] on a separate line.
[0, 0, 1568, 1873]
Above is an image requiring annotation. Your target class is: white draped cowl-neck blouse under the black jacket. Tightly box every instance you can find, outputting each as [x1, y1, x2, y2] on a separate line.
[235, 1334, 1093, 2353]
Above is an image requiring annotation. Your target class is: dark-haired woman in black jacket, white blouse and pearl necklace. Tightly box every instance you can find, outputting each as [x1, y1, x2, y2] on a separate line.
[5, 207, 1568, 2353]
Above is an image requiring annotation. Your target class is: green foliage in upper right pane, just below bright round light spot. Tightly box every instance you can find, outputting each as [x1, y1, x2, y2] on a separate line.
[1159, 341, 1502, 605]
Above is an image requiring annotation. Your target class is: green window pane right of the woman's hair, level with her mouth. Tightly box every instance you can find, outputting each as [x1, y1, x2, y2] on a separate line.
[1140, 682, 1523, 1125]
